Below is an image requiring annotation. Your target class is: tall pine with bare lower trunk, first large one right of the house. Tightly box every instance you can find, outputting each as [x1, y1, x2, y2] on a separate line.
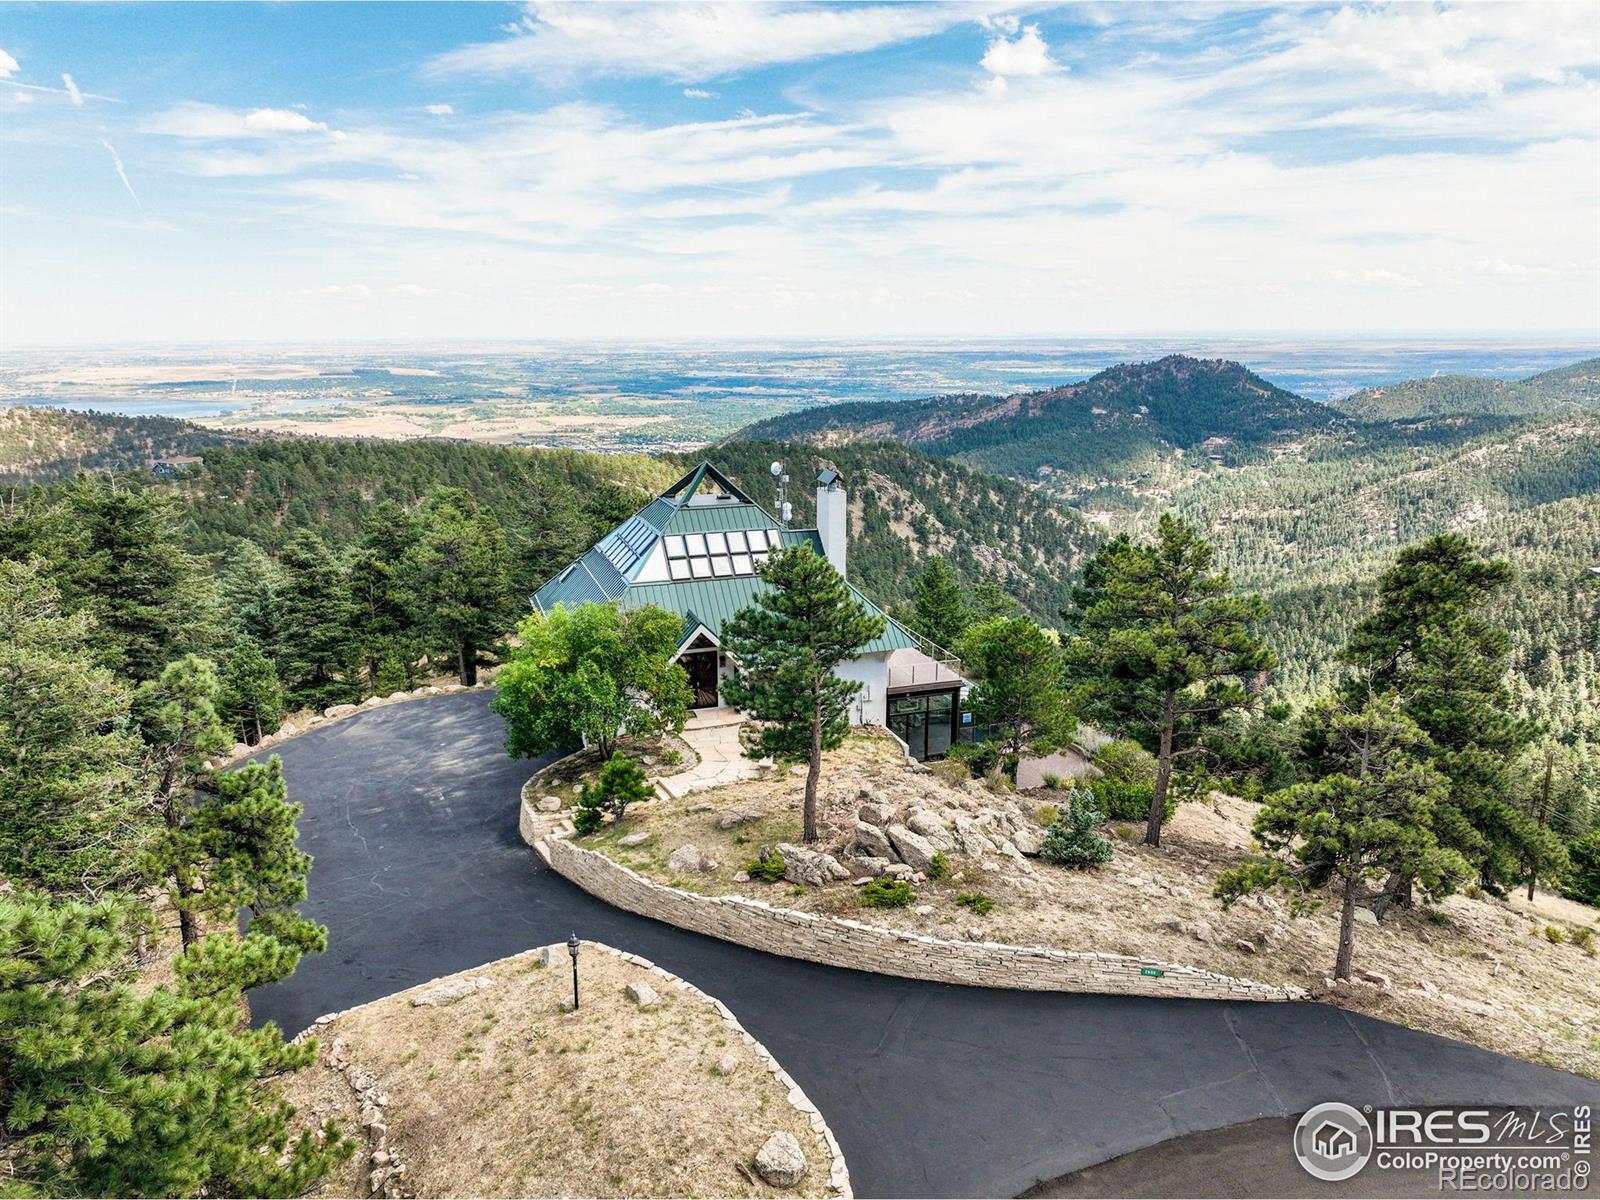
[1067, 514, 1277, 846]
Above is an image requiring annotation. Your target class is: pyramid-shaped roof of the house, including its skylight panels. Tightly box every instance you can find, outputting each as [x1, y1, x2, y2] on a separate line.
[533, 462, 917, 653]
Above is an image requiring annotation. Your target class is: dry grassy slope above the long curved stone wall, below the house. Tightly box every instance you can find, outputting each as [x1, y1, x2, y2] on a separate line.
[581, 734, 1600, 1077]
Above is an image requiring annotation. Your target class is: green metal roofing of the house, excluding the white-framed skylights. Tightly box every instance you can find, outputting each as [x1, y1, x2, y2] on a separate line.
[533, 462, 917, 654]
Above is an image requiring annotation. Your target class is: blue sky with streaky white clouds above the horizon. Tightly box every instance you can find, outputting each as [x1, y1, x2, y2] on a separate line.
[0, 3, 1600, 346]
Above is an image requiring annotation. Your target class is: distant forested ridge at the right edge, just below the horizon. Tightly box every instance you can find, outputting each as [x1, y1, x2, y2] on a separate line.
[1338, 358, 1600, 421]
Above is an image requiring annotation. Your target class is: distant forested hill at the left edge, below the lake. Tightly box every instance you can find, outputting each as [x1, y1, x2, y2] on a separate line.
[0, 408, 250, 485]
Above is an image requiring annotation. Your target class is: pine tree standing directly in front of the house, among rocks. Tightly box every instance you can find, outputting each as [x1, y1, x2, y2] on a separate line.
[722, 546, 883, 842]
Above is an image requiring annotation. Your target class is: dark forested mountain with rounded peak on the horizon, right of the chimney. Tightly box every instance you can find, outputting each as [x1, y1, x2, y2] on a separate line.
[738, 355, 1342, 485]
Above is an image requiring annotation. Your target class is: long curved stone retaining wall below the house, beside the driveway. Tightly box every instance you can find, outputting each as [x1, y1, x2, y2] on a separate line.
[534, 830, 1307, 1000]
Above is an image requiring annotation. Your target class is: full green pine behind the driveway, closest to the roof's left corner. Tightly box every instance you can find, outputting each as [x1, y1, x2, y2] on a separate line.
[406, 488, 515, 686]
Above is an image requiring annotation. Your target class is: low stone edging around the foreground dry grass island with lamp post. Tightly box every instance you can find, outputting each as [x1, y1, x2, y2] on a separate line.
[290, 947, 854, 1200]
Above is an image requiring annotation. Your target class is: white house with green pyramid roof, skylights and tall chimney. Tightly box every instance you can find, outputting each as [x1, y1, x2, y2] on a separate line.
[533, 462, 965, 758]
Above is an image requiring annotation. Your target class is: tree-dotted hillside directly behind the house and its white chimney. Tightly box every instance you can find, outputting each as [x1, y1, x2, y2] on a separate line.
[677, 442, 1101, 630]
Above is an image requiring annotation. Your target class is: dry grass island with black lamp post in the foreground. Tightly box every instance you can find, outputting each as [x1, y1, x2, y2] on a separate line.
[280, 947, 830, 1197]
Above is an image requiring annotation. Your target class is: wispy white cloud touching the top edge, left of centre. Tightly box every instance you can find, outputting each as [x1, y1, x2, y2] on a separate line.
[434, 0, 987, 82]
